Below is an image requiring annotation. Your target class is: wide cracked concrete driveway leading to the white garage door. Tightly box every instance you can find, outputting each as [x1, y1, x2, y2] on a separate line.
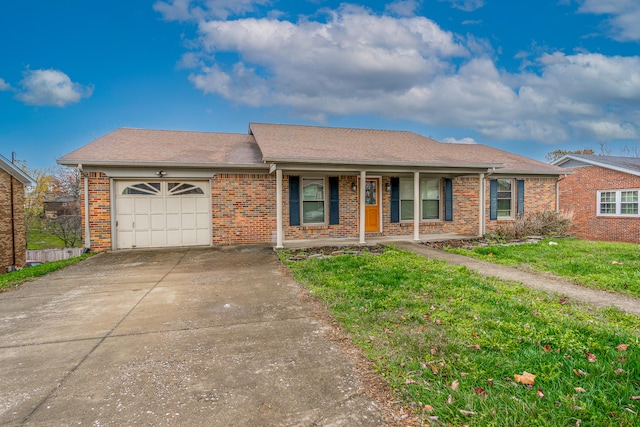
[0, 247, 383, 426]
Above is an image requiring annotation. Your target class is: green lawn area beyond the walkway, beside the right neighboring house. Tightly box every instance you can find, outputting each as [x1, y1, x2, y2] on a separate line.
[448, 239, 640, 298]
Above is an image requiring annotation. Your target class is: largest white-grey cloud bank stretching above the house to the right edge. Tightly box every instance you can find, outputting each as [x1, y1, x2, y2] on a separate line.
[169, 0, 640, 143]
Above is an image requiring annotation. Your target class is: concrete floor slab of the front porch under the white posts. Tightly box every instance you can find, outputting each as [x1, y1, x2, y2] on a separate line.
[277, 233, 478, 249]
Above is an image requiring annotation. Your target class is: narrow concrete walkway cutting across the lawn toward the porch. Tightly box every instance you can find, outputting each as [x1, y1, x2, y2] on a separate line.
[394, 241, 640, 316]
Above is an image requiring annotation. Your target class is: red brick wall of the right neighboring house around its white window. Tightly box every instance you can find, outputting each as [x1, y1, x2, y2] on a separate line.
[560, 166, 640, 243]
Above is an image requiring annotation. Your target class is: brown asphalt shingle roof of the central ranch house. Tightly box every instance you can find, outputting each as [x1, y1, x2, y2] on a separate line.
[58, 123, 565, 175]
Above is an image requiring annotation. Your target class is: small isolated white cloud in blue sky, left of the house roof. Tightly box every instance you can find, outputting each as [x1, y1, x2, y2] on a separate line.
[17, 70, 93, 107]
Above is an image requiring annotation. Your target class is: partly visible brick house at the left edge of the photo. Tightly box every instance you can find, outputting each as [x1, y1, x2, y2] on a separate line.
[0, 155, 33, 274]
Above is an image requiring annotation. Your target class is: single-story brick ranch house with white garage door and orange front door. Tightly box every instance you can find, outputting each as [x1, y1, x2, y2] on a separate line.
[58, 123, 563, 250]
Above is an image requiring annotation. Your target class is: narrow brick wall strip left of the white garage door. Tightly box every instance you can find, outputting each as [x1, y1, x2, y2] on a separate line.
[80, 172, 111, 251]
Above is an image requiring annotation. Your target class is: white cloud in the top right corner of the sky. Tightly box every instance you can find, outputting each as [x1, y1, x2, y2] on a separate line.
[579, 0, 640, 41]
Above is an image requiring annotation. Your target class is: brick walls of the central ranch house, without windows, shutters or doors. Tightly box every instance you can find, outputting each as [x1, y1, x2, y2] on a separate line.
[82, 173, 555, 250]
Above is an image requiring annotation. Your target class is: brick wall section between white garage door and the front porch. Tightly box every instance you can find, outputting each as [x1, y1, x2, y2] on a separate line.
[211, 174, 276, 245]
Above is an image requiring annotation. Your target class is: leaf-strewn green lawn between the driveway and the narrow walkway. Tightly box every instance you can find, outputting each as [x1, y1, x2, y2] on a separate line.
[281, 248, 640, 426]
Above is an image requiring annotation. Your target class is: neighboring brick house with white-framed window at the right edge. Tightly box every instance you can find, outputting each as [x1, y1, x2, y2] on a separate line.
[554, 154, 640, 243]
